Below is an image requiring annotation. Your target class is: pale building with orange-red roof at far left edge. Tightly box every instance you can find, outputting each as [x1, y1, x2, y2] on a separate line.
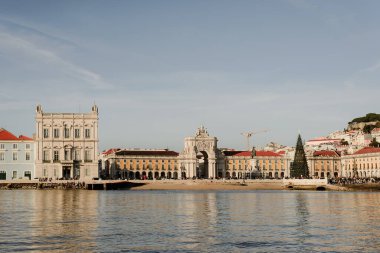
[0, 128, 35, 180]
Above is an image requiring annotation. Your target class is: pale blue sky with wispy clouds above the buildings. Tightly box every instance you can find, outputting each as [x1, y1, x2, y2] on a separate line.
[0, 0, 380, 152]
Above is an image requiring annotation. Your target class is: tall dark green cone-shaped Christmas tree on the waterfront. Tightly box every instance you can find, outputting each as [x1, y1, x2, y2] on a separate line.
[290, 134, 309, 178]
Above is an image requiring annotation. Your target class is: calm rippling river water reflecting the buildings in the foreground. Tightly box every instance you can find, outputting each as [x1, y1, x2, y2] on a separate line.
[0, 190, 380, 252]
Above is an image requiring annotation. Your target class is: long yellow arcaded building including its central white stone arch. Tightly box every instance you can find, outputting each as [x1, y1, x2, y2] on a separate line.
[102, 126, 290, 179]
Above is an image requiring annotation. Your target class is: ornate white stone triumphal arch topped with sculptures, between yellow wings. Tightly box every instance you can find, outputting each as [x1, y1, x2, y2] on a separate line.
[179, 126, 225, 178]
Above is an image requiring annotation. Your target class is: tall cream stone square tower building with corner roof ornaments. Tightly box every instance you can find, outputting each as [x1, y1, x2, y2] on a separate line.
[35, 105, 99, 179]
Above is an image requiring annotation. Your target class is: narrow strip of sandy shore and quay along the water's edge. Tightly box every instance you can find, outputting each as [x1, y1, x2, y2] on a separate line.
[0, 179, 380, 191]
